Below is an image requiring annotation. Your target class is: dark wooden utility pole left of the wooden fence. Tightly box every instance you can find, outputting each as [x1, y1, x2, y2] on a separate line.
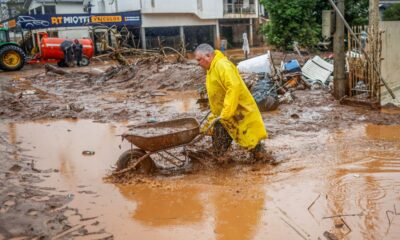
[333, 0, 347, 100]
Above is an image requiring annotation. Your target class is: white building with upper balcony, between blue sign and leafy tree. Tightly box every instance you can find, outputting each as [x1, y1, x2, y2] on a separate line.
[138, 0, 260, 49]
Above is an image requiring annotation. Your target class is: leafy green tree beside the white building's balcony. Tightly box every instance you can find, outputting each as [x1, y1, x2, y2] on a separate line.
[261, 0, 320, 49]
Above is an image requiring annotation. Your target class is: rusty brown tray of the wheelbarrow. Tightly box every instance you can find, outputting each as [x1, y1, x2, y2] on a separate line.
[122, 118, 200, 152]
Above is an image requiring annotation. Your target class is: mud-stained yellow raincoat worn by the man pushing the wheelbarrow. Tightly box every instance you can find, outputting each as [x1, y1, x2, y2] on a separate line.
[205, 50, 267, 149]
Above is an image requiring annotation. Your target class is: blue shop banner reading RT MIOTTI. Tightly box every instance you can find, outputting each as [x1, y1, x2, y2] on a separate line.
[16, 11, 142, 29]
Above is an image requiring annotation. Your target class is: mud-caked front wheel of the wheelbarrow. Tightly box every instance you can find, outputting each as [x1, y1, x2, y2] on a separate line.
[117, 149, 156, 174]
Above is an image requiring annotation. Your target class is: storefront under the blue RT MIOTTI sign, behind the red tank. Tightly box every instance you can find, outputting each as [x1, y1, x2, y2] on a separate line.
[1, 11, 142, 52]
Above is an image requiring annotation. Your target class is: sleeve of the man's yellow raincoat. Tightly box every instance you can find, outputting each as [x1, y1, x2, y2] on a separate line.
[220, 64, 240, 120]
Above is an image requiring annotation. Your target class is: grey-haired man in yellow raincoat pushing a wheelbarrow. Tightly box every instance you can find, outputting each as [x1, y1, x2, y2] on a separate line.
[195, 44, 267, 160]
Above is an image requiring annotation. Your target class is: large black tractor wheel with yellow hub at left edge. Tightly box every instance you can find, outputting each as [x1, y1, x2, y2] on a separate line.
[0, 45, 26, 71]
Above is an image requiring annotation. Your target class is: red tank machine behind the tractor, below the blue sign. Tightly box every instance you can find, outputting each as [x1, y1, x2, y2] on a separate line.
[28, 33, 94, 66]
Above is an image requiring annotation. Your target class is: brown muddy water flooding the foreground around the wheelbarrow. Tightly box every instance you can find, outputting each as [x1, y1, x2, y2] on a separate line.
[1, 121, 400, 240]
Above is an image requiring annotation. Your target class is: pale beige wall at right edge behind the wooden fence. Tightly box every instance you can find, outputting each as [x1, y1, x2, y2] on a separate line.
[379, 21, 400, 106]
